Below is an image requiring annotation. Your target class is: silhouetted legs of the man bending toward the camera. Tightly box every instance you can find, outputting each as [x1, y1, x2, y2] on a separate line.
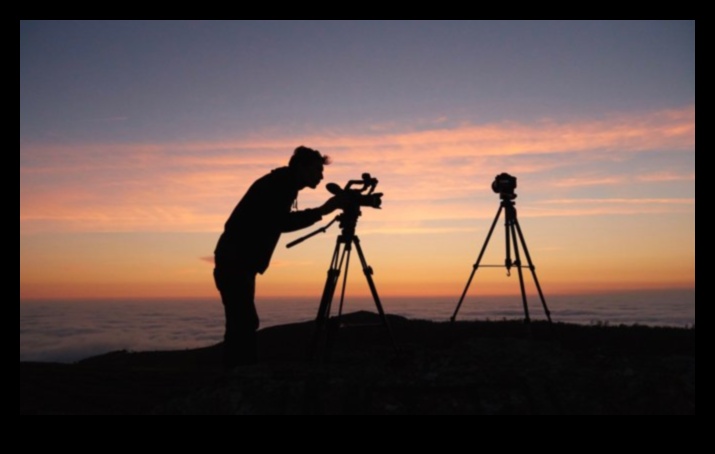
[214, 270, 259, 368]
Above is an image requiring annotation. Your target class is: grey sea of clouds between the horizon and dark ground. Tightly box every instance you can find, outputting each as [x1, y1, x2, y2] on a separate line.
[20, 290, 695, 362]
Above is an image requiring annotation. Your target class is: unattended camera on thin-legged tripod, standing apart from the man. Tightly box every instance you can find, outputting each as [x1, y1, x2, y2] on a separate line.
[451, 173, 552, 326]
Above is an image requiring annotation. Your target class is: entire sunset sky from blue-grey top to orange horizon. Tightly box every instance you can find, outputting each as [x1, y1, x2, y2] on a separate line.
[20, 21, 695, 300]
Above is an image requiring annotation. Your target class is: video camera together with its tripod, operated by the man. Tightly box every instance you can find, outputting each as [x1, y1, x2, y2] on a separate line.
[286, 173, 397, 361]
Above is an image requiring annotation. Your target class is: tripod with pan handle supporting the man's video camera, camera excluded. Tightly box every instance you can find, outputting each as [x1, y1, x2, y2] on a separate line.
[288, 206, 397, 361]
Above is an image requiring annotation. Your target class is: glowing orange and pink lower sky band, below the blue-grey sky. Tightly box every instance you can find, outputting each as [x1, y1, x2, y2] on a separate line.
[20, 106, 695, 299]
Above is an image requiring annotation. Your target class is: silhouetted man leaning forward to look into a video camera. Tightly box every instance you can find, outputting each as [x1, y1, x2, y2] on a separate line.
[214, 146, 338, 368]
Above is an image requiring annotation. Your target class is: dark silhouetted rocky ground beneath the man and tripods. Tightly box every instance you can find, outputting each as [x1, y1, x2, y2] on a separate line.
[20, 312, 695, 415]
